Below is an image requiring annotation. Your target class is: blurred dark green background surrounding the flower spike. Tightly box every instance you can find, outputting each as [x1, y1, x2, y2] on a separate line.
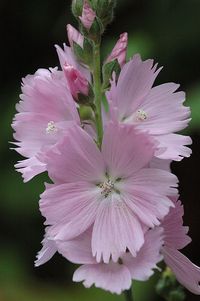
[0, 0, 200, 301]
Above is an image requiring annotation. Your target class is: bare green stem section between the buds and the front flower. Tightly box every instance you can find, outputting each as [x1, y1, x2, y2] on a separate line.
[93, 43, 103, 148]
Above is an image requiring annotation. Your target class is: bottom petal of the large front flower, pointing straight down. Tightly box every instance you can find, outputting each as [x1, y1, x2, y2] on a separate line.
[92, 194, 144, 263]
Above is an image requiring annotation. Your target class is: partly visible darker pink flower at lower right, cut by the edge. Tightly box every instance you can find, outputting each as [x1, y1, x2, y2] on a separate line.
[162, 201, 200, 295]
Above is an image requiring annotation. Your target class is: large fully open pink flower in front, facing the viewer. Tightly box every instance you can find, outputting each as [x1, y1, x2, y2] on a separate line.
[40, 123, 177, 263]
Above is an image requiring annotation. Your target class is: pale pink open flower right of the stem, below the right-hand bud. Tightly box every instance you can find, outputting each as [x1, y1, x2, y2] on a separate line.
[107, 55, 191, 161]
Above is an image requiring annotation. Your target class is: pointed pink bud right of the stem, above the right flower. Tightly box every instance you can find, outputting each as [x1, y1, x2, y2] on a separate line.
[106, 32, 128, 67]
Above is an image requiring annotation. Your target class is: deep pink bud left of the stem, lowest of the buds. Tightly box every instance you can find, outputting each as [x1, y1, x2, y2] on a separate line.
[63, 63, 89, 100]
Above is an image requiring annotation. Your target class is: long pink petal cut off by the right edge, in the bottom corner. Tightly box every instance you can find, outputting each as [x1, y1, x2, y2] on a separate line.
[162, 247, 200, 295]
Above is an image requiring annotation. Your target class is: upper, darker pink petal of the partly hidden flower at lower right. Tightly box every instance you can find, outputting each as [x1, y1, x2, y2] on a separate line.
[162, 201, 191, 249]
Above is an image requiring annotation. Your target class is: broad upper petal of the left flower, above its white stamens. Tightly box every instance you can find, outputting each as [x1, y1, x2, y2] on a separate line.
[16, 69, 79, 121]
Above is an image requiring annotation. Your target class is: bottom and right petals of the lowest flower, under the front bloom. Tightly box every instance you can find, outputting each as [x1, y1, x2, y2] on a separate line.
[73, 228, 163, 294]
